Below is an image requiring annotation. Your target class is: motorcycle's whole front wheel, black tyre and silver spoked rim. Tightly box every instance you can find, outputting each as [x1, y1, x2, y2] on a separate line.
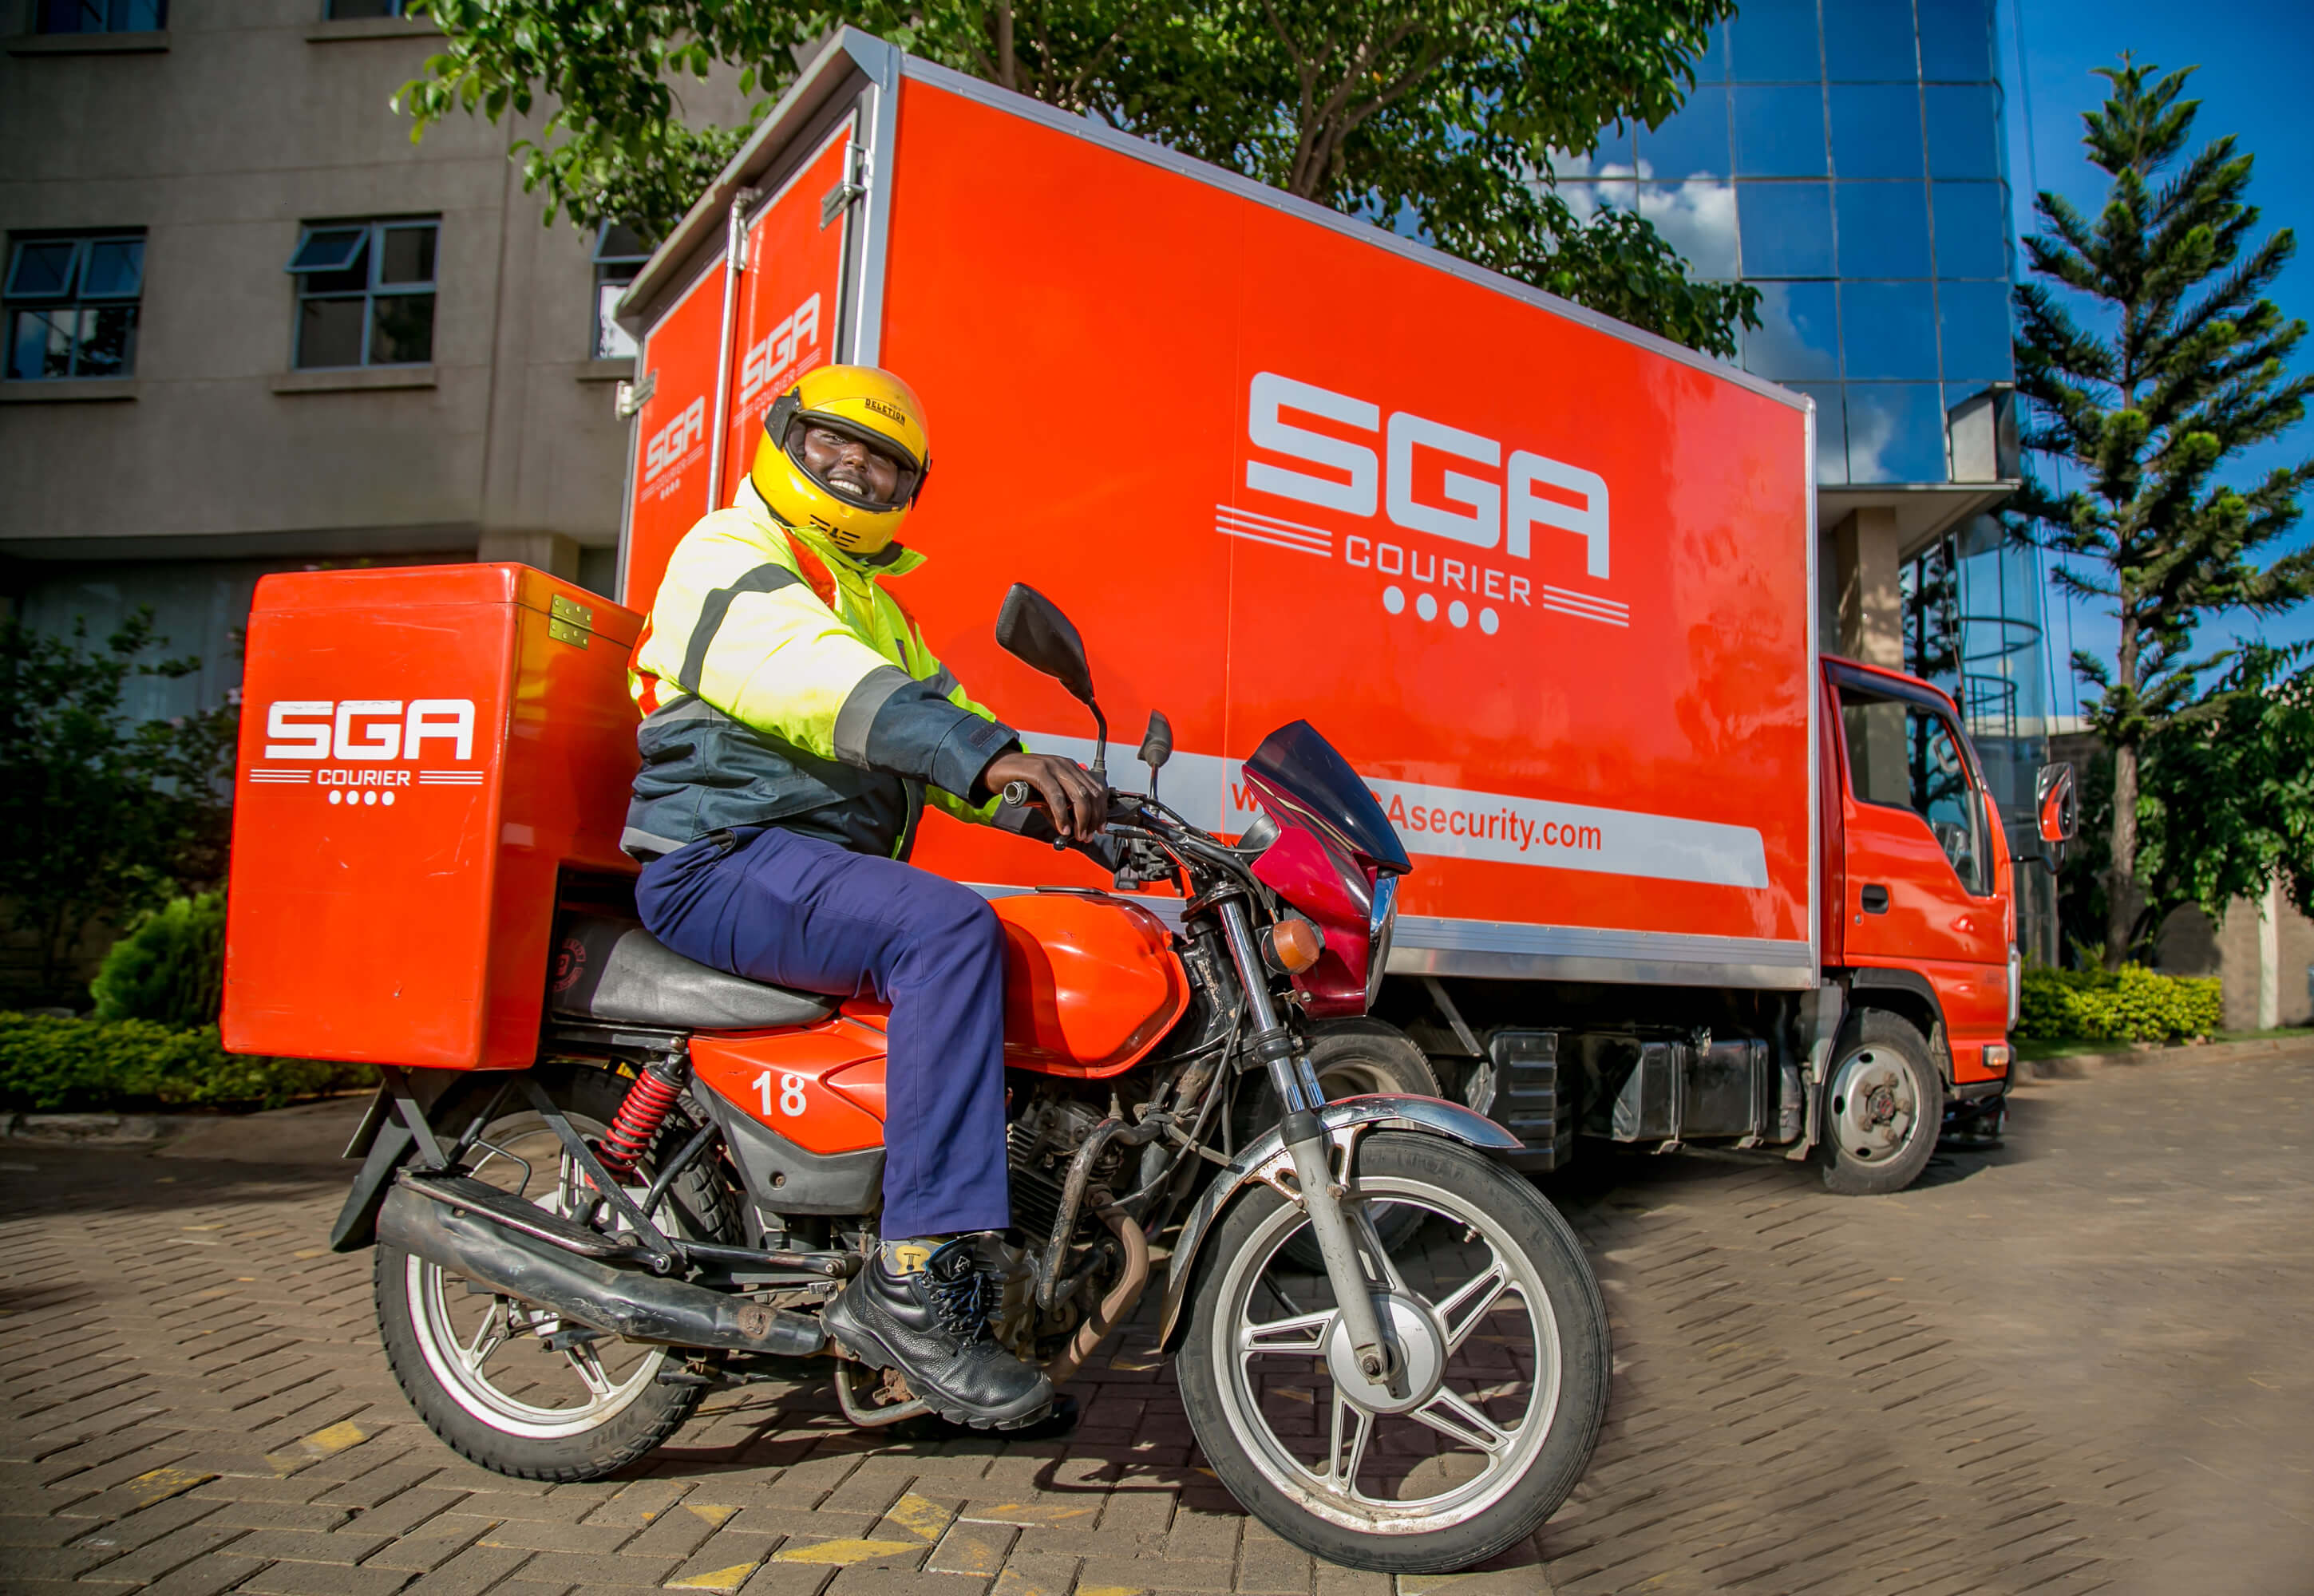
[1178, 1131, 1613, 1573]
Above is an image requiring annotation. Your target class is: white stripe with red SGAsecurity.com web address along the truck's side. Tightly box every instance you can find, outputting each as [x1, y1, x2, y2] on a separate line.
[1025, 733, 1768, 891]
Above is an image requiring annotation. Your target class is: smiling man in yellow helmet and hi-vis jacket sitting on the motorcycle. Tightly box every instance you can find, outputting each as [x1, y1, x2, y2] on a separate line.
[625, 365, 1104, 1427]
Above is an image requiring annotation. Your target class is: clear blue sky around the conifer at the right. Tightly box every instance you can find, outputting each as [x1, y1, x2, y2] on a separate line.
[2000, 0, 2314, 713]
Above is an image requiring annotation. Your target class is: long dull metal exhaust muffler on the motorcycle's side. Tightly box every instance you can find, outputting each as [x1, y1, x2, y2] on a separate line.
[378, 1187, 829, 1357]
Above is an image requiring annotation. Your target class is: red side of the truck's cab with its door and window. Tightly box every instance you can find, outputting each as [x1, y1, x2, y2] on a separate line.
[1835, 671, 2008, 1080]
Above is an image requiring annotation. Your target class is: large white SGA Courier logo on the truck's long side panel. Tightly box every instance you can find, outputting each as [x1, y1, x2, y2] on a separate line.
[1215, 373, 1632, 634]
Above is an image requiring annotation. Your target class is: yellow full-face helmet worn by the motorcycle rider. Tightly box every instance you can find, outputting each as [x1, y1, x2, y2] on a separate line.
[752, 365, 932, 555]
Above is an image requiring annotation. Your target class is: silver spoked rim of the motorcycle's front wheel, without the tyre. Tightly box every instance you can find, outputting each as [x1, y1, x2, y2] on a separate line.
[1212, 1175, 1562, 1536]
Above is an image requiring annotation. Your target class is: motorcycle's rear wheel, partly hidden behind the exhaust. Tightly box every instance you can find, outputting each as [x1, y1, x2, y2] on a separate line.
[373, 1069, 736, 1485]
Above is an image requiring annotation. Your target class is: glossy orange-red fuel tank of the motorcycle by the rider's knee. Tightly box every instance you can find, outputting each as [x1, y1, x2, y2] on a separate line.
[993, 891, 1189, 1078]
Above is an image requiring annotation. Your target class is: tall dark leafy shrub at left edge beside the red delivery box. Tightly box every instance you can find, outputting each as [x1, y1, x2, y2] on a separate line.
[0, 610, 239, 1001]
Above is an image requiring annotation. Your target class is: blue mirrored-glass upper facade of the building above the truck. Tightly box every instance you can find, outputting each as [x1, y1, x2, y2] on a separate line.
[1562, 0, 2013, 486]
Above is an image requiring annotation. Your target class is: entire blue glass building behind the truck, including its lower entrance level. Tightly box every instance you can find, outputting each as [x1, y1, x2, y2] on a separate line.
[1560, 0, 2055, 958]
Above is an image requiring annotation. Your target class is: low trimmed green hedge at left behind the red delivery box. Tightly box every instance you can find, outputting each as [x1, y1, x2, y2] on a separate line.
[0, 1011, 378, 1112]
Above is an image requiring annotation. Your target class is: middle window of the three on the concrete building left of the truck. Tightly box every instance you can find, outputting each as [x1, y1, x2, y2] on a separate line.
[289, 217, 442, 370]
